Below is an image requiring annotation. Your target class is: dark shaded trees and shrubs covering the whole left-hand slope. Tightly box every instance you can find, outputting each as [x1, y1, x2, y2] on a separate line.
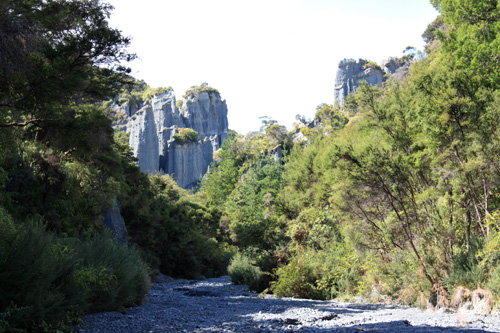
[0, 0, 231, 332]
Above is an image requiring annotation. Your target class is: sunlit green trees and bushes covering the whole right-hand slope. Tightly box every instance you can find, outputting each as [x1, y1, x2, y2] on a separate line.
[196, 0, 500, 305]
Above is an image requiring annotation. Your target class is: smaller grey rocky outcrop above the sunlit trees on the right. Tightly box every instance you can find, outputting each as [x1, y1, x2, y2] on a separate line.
[333, 58, 402, 105]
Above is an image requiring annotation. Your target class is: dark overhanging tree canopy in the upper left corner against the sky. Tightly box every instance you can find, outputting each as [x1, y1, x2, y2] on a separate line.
[0, 0, 134, 133]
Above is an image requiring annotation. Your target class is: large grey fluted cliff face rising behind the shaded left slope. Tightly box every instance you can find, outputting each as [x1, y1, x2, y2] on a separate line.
[115, 90, 228, 189]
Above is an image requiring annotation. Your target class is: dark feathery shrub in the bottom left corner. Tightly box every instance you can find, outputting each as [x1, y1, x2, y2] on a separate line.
[0, 220, 86, 331]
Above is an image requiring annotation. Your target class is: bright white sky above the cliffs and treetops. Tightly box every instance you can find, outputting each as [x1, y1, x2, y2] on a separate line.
[106, 0, 438, 134]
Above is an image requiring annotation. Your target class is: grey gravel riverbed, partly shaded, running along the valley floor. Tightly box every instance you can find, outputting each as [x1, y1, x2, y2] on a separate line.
[75, 276, 500, 333]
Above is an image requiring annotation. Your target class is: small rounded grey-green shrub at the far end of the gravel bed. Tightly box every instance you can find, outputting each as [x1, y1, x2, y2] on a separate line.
[227, 253, 263, 291]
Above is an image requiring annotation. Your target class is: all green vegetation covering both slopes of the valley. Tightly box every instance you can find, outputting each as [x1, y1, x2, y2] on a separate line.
[0, 0, 500, 331]
